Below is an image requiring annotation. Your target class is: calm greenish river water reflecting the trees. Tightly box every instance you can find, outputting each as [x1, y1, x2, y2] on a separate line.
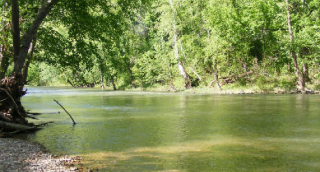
[22, 87, 320, 172]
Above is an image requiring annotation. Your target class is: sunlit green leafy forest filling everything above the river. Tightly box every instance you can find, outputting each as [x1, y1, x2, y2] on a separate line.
[0, 0, 320, 91]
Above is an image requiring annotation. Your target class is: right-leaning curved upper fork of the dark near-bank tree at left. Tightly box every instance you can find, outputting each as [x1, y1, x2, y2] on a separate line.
[12, 0, 59, 77]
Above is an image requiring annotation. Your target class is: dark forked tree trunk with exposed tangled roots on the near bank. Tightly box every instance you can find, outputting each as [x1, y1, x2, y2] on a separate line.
[0, 0, 59, 135]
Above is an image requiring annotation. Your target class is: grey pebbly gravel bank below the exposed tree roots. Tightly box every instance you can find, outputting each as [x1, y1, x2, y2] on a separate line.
[0, 138, 82, 172]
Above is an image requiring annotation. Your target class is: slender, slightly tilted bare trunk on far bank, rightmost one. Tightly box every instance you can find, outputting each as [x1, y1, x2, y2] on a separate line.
[285, 0, 305, 91]
